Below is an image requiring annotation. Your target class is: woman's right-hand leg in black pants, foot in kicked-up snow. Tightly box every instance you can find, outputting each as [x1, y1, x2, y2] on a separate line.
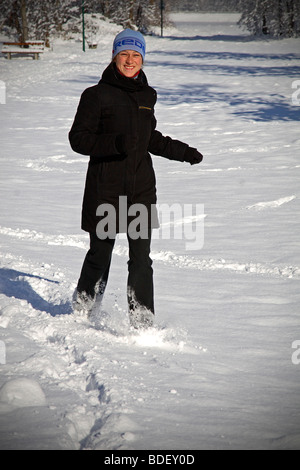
[128, 231, 154, 327]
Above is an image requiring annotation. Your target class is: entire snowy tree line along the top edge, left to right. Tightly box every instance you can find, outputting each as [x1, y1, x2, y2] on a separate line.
[0, 0, 300, 40]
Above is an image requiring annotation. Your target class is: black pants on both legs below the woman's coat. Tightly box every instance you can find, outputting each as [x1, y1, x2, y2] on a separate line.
[77, 232, 154, 314]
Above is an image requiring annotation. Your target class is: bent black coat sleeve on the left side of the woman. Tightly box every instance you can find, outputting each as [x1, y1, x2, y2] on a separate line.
[69, 87, 119, 157]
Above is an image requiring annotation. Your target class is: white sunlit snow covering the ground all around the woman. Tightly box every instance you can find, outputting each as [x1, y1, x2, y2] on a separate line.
[0, 13, 300, 450]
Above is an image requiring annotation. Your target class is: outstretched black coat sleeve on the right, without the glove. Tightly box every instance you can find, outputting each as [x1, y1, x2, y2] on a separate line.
[148, 117, 188, 162]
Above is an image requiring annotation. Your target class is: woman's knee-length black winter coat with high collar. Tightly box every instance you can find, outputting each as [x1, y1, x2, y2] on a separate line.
[69, 63, 188, 233]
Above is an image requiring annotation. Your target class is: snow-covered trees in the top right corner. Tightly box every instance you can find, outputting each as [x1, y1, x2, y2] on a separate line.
[239, 0, 300, 37]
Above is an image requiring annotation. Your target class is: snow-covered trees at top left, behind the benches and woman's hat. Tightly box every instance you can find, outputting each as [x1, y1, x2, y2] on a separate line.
[0, 0, 170, 39]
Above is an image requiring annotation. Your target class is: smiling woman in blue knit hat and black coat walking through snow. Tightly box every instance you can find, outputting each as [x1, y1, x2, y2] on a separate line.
[69, 29, 203, 328]
